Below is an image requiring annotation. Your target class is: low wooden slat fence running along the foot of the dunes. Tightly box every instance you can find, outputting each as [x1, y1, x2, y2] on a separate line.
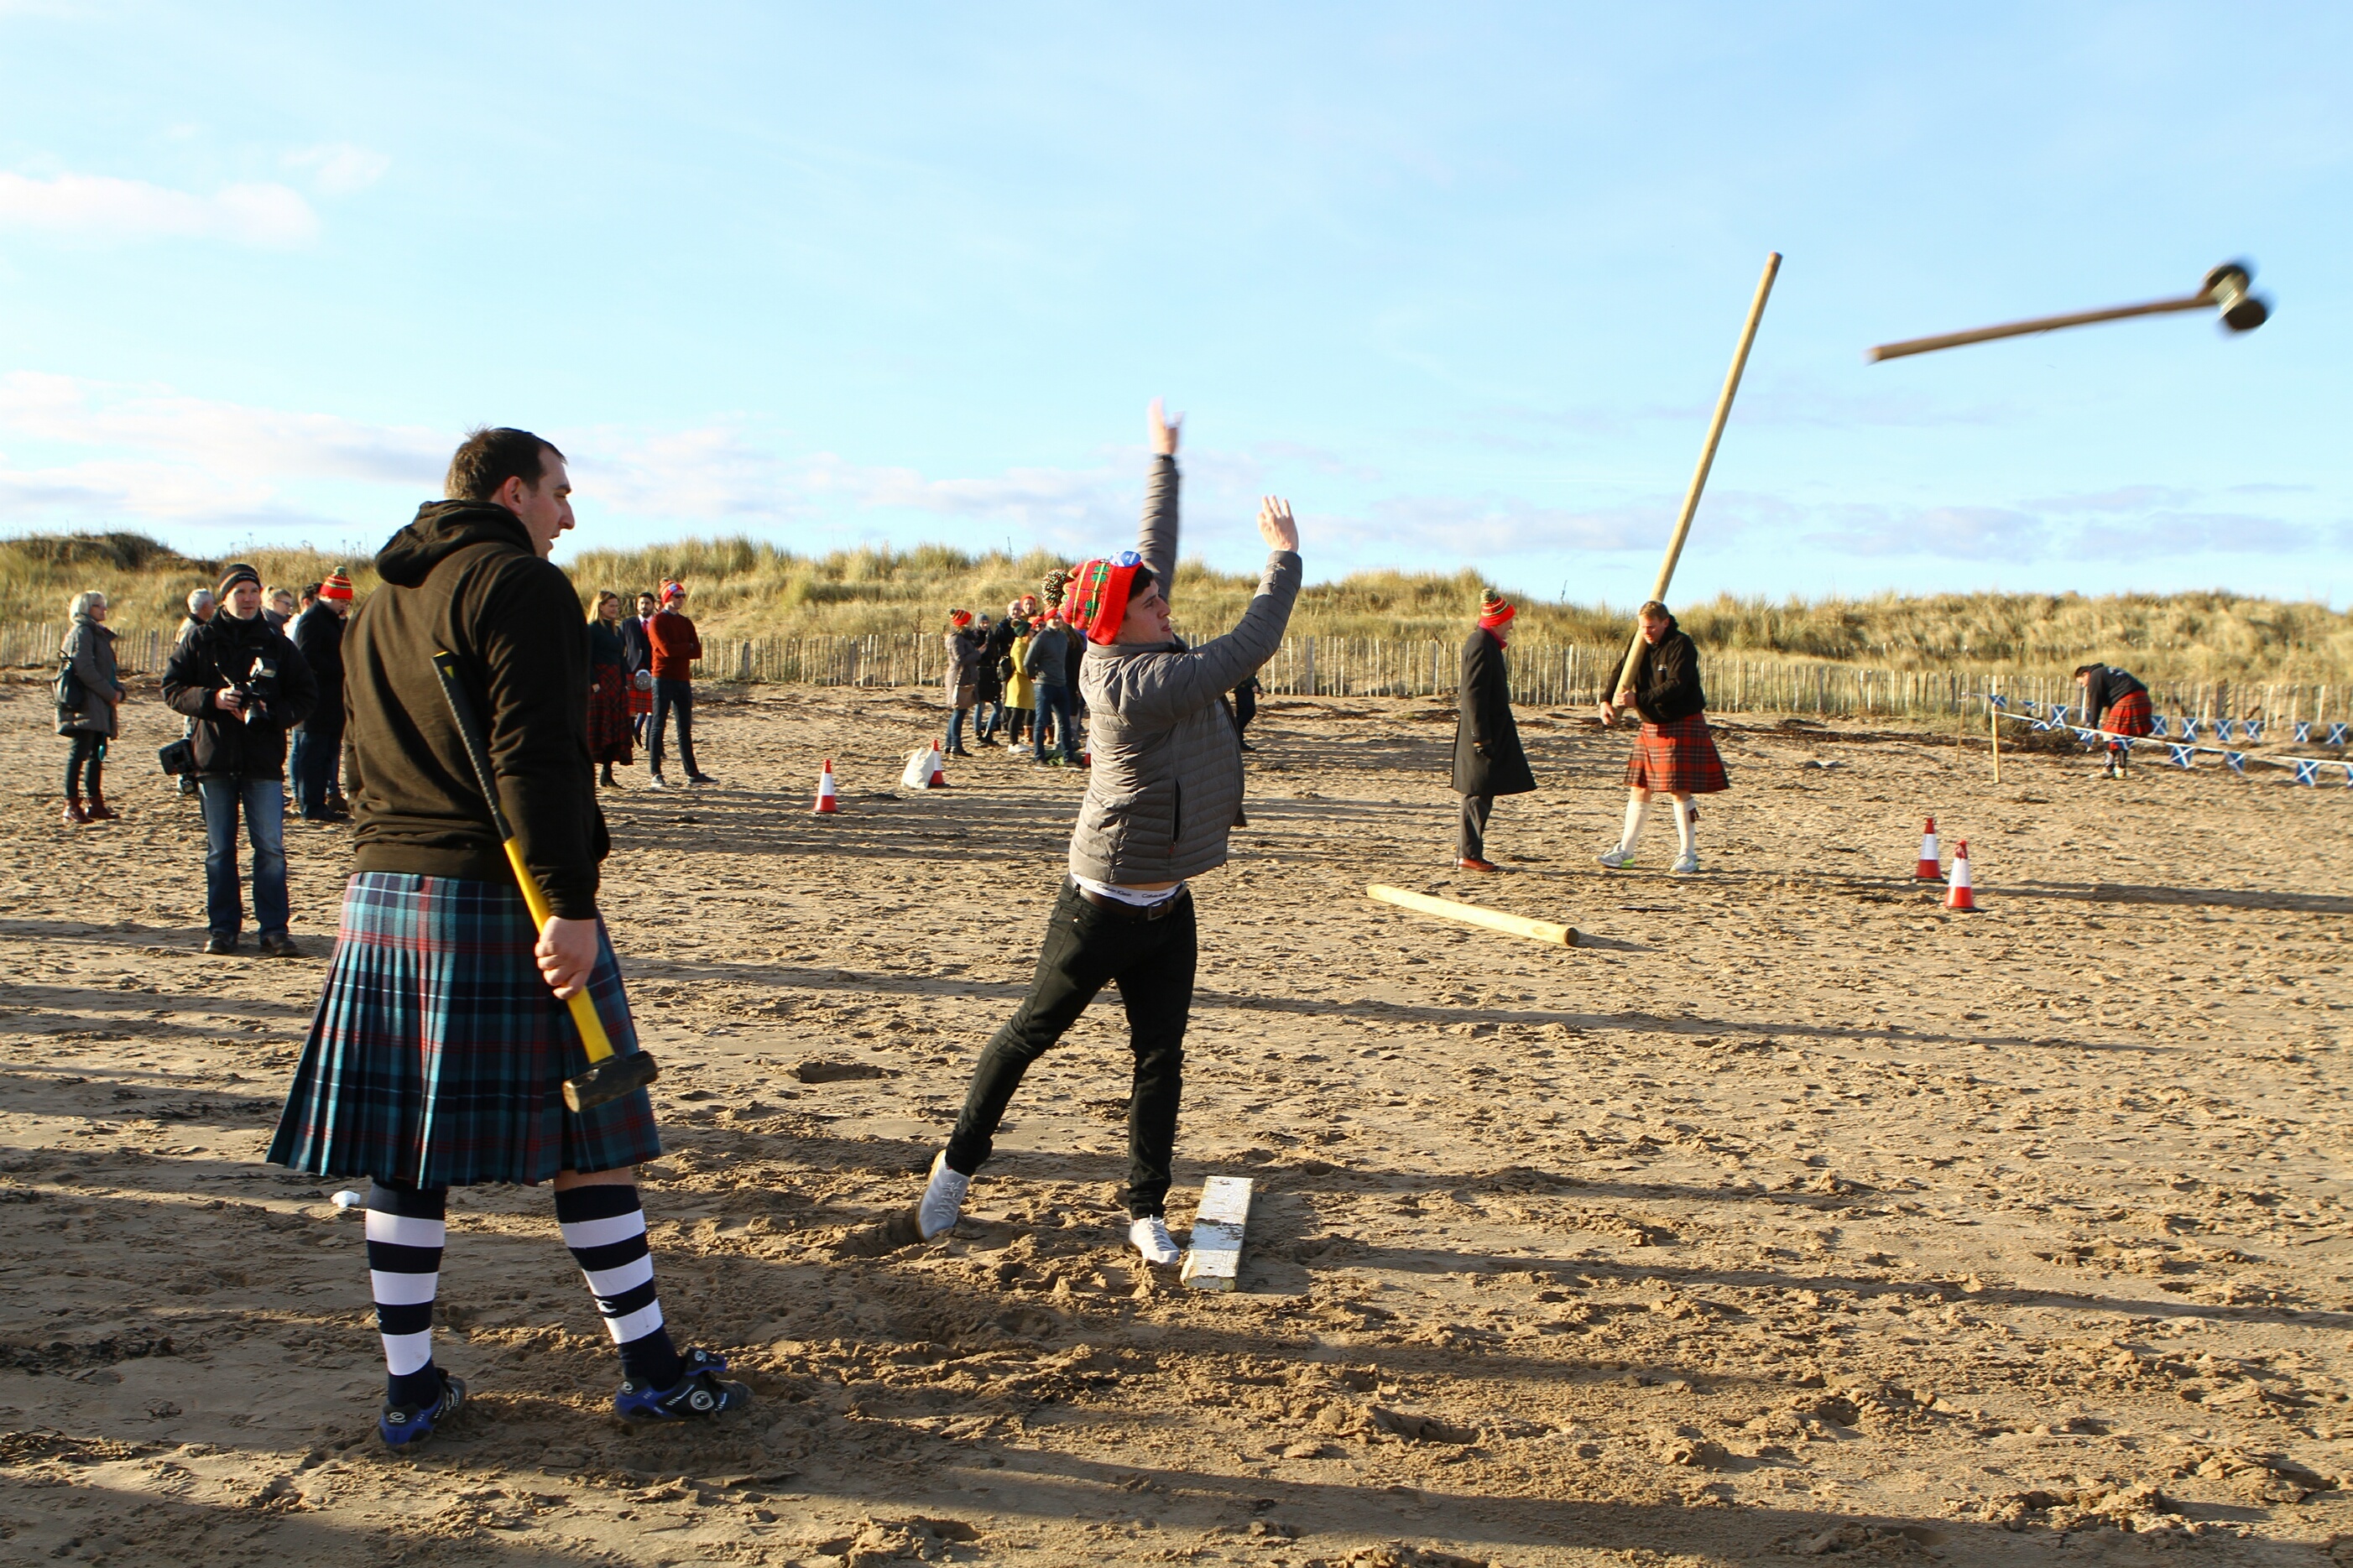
[0, 623, 2346, 724]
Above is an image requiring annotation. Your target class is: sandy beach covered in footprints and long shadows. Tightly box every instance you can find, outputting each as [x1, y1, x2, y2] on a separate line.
[0, 682, 2353, 1568]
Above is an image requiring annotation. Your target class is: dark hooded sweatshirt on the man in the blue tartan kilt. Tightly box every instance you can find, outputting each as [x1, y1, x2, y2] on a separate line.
[343, 501, 612, 919]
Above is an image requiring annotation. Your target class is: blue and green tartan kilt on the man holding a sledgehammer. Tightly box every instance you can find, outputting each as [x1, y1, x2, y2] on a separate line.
[269, 873, 661, 1187]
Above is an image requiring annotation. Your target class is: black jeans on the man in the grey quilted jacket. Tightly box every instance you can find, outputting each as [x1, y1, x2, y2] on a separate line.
[948, 882, 1197, 1220]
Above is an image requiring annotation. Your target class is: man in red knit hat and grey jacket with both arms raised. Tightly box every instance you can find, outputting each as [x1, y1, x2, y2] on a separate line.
[916, 399, 1299, 1265]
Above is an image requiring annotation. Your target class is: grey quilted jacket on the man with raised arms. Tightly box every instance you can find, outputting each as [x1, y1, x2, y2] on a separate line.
[1071, 458, 1299, 884]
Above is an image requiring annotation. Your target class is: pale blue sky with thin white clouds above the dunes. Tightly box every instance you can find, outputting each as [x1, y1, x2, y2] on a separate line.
[0, 0, 2353, 607]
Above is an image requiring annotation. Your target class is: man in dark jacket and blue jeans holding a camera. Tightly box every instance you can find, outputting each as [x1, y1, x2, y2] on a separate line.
[162, 562, 318, 956]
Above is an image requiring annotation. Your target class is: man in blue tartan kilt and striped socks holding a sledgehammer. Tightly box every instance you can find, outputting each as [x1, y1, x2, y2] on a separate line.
[269, 430, 750, 1446]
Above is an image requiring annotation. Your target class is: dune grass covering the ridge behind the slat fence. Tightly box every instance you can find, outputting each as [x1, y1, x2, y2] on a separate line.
[0, 534, 2353, 682]
